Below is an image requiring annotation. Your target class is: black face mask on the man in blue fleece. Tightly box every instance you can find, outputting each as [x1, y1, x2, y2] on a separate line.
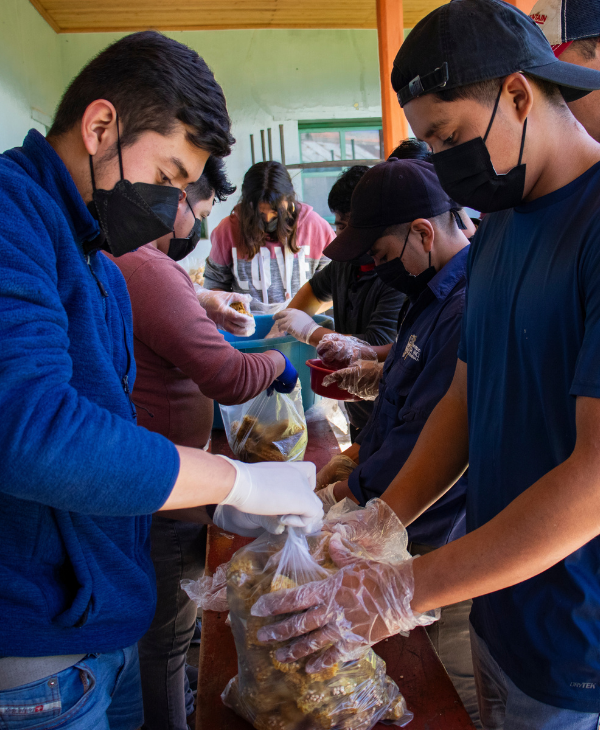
[88, 120, 180, 256]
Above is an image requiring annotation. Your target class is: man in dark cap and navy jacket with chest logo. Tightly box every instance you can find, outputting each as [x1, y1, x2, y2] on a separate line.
[318, 160, 478, 722]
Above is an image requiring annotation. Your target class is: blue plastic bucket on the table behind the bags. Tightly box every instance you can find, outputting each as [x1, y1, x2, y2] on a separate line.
[213, 314, 333, 429]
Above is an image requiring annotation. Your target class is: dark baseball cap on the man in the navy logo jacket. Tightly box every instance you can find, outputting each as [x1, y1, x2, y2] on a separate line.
[323, 157, 461, 261]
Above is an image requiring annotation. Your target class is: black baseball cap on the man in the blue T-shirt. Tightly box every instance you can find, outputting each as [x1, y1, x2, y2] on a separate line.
[392, 0, 600, 106]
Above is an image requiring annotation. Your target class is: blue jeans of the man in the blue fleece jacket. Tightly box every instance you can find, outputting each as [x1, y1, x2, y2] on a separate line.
[0, 646, 143, 730]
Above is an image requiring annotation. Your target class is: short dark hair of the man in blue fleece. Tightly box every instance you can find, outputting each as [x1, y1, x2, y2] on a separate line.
[48, 31, 235, 157]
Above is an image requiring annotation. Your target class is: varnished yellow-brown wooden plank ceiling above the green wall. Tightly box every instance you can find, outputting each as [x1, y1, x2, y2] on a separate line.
[30, 0, 447, 33]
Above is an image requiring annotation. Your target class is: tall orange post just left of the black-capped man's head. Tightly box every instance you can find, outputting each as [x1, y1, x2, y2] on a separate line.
[377, 0, 408, 157]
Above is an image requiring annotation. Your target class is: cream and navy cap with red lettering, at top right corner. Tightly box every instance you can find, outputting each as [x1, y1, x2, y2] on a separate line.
[529, 0, 600, 58]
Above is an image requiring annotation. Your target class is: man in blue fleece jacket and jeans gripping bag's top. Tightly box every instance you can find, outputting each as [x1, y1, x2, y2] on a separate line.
[0, 32, 321, 730]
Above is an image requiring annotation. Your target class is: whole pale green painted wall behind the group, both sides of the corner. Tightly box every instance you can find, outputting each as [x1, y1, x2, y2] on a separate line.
[0, 0, 381, 245]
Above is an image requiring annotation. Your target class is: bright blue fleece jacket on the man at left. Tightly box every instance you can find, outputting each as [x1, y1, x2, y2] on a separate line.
[0, 131, 179, 656]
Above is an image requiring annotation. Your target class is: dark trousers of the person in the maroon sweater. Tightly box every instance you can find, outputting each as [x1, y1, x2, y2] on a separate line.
[138, 515, 206, 730]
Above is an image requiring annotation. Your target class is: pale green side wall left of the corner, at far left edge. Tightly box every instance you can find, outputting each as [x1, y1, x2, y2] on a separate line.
[0, 0, 64, 150]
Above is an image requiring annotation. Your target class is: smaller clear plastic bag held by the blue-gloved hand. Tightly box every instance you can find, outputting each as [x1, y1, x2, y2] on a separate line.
[221, 381, 308, 463]
